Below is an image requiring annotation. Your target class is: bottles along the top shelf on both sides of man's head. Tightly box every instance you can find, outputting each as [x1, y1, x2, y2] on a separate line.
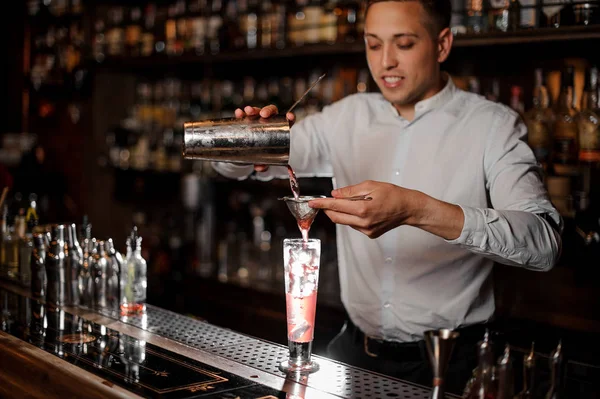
[93, 0, 600, 61]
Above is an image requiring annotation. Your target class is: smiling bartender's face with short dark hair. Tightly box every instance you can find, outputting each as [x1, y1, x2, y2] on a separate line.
[365, 1, 439, 106]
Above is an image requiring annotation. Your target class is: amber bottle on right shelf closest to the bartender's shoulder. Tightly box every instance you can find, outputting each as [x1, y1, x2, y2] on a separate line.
[524, 68, 554, 168]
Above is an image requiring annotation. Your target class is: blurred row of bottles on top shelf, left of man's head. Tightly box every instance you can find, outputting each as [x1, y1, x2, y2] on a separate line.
[93, 0, 366, 61]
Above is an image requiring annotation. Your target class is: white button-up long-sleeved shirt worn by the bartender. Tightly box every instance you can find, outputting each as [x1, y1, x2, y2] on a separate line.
[213, 78, 563, 342]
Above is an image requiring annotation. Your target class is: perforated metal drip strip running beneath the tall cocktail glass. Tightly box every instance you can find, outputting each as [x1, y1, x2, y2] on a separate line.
[100, 305, 446, 399]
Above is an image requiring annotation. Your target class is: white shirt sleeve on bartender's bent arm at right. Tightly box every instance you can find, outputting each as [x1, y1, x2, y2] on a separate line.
[448, 112, 563, 271]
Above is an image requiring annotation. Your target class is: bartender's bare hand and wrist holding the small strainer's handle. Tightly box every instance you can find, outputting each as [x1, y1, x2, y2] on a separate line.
[309, 181, 464, 240]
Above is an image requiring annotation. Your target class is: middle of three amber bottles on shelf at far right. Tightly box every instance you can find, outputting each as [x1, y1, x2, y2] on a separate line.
[552, 66, 579, 176]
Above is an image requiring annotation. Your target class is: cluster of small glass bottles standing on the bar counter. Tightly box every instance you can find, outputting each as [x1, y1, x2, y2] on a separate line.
[0, 201, 147, 315]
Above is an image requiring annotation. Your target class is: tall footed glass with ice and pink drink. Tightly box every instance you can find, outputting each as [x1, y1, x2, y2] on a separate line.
[279, 239, 321, 372]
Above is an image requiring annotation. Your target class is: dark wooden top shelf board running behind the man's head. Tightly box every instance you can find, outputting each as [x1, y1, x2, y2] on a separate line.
[91, 25, 600, 69]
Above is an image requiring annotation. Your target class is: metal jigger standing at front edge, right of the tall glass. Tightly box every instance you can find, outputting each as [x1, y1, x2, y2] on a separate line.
[425, 329, 459, 399]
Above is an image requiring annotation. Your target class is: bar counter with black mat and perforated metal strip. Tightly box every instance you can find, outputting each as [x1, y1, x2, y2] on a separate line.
[0, 281, 454, 399]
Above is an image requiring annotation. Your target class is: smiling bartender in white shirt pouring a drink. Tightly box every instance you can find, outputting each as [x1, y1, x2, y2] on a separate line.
[213, 0, 563, 393]
